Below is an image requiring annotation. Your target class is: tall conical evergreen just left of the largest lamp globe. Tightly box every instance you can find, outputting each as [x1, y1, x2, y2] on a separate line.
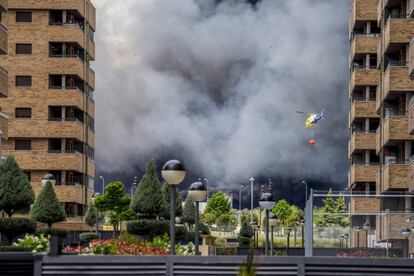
[131, 160, 163, 217]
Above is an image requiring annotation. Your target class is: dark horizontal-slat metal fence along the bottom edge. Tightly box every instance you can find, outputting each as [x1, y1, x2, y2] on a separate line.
[0, 254, 414, 276]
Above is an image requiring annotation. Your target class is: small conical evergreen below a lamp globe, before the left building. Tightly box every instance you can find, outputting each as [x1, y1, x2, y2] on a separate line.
[30, 181, 66, 228]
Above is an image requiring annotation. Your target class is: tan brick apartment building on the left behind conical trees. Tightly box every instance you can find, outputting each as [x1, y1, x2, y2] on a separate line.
[0, 0, 95, 230]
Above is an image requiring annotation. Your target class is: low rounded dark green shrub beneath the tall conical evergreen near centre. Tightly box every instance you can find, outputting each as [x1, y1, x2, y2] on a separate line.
[127, 219, 169, 240]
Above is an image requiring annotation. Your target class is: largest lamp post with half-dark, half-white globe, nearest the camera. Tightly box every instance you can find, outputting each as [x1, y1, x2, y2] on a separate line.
[161, 160, 186, 255]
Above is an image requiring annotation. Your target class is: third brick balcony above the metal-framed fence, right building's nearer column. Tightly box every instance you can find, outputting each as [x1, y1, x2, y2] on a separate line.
[381, 65, 414, 100]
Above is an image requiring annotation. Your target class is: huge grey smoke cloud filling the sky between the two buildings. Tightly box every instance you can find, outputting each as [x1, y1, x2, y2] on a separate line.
[95, 0, 351, 188]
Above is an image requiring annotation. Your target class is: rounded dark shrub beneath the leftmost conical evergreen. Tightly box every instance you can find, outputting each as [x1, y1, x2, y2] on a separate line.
[0, 218, 36, 243]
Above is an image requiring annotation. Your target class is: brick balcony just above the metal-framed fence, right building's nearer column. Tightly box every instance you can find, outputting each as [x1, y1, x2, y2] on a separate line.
[380, 161, 410, 193]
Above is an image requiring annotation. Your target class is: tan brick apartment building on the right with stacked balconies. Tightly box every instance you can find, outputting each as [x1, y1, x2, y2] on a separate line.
[349, 0, 414, 253]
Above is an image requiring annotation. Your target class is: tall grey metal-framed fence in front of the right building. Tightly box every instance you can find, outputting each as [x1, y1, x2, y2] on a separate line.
[305, 192, 414, 258]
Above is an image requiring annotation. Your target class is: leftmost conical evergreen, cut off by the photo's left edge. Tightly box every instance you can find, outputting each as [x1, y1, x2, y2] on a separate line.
[0, 156, 35, 217]
